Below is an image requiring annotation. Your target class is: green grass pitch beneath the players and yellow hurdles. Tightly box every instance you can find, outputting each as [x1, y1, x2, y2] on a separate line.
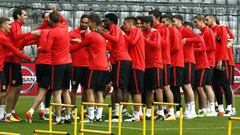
[0, 96, 240, 135]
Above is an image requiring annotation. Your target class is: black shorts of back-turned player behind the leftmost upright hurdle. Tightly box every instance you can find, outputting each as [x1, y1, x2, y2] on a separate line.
[51, 64, 71, 90]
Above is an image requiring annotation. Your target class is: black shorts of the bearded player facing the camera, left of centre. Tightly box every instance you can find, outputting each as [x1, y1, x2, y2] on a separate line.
[71, 66, 89, 90]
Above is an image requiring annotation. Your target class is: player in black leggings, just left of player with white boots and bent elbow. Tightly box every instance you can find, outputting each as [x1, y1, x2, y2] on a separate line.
[161, 14, 184, 117]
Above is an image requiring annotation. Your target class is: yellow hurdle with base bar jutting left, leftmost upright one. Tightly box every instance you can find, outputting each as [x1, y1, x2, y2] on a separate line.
[34, 103, 78, 135]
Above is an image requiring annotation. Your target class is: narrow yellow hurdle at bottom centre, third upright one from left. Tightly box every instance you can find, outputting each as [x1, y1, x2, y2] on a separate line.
[118, 102, 146, 135]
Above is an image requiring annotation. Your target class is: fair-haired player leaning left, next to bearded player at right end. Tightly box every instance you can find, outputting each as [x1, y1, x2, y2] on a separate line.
[194, 15, 216, 117]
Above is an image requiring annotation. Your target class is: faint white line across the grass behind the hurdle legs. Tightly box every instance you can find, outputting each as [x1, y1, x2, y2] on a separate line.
[85, 124, 240, 131]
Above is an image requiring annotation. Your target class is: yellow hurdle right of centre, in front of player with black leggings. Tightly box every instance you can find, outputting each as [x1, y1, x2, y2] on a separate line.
[151, 102, 183, 135]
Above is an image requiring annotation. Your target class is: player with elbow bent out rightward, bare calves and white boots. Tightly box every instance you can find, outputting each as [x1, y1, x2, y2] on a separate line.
[173, 15, 200, 119]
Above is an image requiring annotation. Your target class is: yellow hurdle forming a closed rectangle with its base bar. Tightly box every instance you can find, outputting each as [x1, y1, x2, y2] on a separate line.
[79, 102, 113, 135]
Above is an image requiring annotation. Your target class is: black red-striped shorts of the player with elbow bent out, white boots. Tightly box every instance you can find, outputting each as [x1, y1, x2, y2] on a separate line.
[183, 63, 195, 85]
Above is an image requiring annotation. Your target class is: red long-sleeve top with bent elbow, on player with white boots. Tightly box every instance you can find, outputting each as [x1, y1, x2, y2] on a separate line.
[178, 26, 201, 64]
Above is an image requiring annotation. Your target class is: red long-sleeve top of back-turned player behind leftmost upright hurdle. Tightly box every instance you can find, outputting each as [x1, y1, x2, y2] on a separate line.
[39, 23, 72, 65]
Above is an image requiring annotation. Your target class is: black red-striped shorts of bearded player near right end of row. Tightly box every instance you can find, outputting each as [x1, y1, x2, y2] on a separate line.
[213, 61, 230, 86]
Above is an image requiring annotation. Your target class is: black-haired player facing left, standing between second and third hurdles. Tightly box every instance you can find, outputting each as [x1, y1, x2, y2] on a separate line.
[96, 13, 132, 118]
